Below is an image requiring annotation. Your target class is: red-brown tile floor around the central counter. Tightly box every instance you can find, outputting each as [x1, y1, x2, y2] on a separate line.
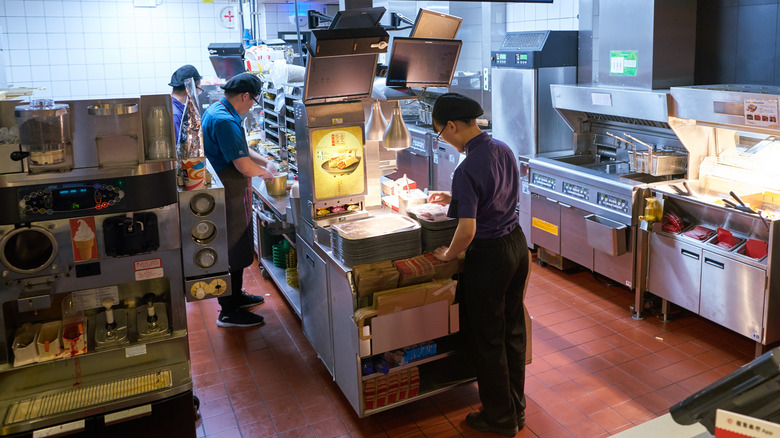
[187, 256, 754, 438]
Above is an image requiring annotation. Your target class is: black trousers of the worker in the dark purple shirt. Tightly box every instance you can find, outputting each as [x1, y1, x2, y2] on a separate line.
[458, 227, 529, 423]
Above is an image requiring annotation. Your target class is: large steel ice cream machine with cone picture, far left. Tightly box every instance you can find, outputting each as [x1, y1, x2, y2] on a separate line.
[0, 95, 195, 436]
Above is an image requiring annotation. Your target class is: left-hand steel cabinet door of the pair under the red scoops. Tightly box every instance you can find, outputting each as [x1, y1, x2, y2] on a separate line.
[647, 233, 702, 313]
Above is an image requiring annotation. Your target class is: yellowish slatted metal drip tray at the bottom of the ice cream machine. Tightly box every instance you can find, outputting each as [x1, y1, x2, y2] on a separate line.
[5, 369, 173, 424]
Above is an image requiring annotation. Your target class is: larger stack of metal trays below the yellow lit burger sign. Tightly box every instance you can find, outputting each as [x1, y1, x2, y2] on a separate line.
[330, 214, 422, 268]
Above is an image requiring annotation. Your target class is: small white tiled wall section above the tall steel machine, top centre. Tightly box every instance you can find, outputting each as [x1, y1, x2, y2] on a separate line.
[506, 0, 579, 32]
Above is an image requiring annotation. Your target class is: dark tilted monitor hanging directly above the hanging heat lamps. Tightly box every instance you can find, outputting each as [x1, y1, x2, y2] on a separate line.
[387, 37, 462, 87]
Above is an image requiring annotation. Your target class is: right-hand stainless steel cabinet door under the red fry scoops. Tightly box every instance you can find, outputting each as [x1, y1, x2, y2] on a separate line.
[700, 250, 766, 342]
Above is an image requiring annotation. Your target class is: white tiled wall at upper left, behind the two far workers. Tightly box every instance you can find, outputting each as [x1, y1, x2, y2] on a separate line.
[0, 0, 240, 99]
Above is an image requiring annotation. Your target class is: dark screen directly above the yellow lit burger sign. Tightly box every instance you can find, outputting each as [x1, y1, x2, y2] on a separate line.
[303, 53, 377, 103]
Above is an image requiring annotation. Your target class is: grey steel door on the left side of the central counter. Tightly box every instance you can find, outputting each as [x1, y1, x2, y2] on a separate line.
[296, 239, 333, 374]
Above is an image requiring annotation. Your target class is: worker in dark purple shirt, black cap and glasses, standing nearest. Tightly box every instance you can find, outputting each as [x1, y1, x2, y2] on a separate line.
[429, 93, 530, 436]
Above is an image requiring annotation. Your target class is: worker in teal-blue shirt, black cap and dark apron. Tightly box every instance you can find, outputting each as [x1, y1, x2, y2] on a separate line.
[202, 73, 277, 327]
